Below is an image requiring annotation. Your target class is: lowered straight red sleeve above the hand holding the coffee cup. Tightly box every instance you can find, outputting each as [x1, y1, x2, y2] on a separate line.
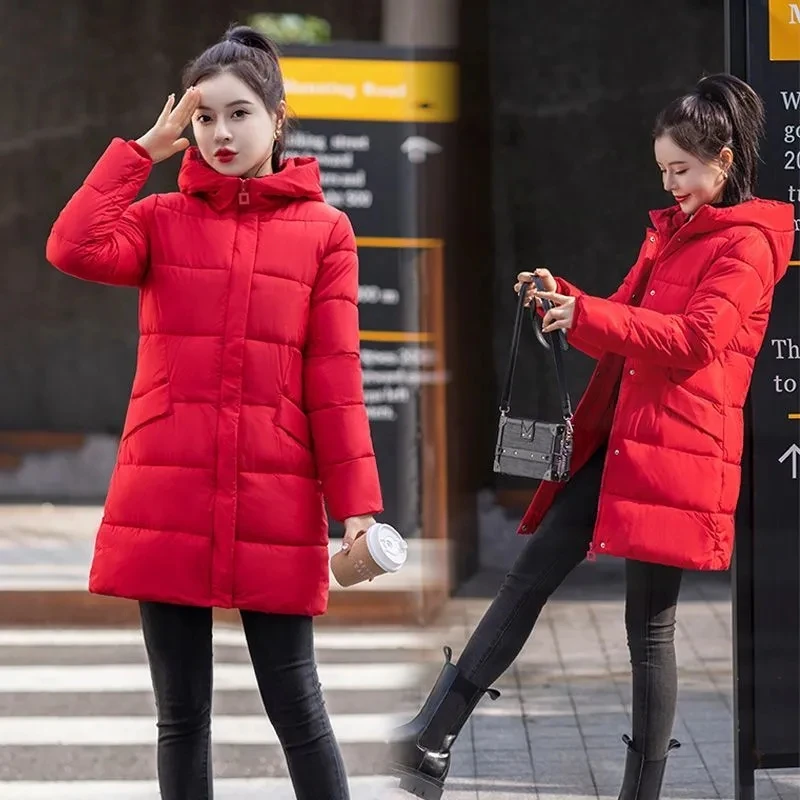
[303, 214, 383, 521]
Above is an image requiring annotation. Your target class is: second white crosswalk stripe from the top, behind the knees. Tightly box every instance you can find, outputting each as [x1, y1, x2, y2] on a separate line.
[0, 663, 423, 694]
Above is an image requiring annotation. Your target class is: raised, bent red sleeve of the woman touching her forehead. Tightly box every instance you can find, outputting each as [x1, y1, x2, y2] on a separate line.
[47, 139, 156, 286]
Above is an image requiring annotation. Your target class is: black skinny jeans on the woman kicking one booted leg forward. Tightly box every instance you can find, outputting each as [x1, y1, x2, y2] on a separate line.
[458, 447, 683, 759]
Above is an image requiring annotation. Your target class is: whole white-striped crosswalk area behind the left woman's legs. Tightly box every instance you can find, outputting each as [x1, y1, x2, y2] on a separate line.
[0, 623, 418, 784]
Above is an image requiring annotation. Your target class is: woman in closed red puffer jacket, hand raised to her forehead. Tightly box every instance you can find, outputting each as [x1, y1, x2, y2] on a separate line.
[47, 27, 382, 800]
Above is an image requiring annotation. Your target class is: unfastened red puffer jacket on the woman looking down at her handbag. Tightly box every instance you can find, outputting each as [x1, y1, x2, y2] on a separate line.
[519, 199, 794, 570]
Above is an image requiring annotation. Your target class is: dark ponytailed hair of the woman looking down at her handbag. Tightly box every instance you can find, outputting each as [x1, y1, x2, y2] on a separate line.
[653, 74, 764, 205]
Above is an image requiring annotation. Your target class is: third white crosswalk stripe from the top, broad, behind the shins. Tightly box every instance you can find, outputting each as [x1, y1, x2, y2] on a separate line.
[0, 714, 402, 748]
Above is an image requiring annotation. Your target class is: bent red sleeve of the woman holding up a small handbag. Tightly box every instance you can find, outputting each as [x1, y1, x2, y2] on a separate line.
[571, 231, 773, 370]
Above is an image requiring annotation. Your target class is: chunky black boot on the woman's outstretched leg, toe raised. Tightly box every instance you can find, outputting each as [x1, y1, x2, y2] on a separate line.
[389, 647, 500, 800]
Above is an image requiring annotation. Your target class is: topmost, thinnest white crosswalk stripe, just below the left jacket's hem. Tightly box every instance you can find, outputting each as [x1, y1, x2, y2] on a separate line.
[0, 626, 438, 650]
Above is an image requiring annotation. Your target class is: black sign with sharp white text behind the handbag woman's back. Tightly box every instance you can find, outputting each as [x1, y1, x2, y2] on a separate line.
[728, 0, 800, 798]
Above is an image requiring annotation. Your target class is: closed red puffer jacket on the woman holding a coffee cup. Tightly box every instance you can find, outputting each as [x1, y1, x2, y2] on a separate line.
[47, 139, 382, 615]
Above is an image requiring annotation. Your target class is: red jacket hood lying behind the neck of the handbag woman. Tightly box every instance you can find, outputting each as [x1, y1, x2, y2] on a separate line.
[650, 198, 795, 283]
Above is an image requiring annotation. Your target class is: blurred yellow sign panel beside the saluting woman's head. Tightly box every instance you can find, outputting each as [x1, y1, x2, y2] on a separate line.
[281, 57, 458, 122]
